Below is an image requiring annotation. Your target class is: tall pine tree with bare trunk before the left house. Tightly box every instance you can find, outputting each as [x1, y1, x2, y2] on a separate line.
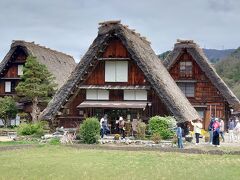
[16, 56, 56, 122]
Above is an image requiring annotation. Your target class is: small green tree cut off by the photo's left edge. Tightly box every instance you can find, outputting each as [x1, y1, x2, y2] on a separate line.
[0, 96, 17, 127]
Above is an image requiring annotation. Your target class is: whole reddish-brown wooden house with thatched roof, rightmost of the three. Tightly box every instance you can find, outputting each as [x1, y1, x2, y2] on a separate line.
[164, 40, 240, 129]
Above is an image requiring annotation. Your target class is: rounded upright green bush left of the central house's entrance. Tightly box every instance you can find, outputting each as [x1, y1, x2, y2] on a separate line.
[80, 117, 100, 144]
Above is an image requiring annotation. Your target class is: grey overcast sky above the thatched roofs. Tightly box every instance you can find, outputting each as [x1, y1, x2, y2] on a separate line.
[0, 0, 240, 61]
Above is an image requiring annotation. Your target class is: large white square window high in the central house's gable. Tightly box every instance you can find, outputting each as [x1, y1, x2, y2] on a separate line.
[105, 61, 128, 82]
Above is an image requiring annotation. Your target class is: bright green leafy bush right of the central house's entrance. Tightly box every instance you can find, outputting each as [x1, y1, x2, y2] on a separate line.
[149, 116, 174, 139]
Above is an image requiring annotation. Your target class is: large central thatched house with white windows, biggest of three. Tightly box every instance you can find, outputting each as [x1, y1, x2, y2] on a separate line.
[40, 21, 199, 128]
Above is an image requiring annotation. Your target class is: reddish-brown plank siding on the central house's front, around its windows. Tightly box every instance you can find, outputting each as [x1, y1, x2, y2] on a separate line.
[57, 39, 170, 127]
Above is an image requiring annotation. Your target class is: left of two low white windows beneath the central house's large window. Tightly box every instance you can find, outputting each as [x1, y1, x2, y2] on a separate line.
[86, 89, 109, 100]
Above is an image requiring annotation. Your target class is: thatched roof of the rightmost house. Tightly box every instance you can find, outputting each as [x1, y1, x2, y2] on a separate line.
[163, 40, 240, 109]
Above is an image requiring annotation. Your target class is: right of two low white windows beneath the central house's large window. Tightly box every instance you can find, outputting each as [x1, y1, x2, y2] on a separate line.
[124, 90, 147, 101]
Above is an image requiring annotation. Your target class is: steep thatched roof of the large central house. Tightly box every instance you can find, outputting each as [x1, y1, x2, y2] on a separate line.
[41, 21, 199, 121]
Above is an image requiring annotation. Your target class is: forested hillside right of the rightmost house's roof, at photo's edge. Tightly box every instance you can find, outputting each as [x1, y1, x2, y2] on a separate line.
[215, 48, 240, 99]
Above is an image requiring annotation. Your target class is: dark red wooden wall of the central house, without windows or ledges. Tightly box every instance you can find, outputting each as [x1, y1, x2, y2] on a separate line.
[58, 40, 169, 127]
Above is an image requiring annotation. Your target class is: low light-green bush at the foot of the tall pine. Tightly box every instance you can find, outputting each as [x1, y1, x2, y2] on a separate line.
[17, 122, 45, 137]
